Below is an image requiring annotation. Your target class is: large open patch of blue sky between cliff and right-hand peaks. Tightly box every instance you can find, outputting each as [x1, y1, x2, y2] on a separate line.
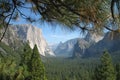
[37, 24, 80, 45]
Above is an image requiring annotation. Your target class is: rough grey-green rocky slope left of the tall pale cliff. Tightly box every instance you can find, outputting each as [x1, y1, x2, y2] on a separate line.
[0, 26, 23, 49]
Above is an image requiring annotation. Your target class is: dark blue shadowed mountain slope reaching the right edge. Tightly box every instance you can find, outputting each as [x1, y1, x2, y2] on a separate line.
[84, 32, 120, 57]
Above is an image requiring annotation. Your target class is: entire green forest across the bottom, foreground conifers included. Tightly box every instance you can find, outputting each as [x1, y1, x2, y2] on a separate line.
[0, 43, 120, 80]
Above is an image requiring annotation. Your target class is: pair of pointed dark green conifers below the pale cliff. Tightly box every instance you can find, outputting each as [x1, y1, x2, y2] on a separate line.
[18, 43, 46, 80]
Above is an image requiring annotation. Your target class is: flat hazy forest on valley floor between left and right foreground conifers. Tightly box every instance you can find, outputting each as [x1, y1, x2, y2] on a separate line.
[44, 58, 98, 80]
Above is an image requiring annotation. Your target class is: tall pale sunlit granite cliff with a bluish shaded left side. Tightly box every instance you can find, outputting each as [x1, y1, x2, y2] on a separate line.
[1, 24, 54, 56]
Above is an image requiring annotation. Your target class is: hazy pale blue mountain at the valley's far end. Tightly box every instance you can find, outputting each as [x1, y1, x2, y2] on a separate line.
[54, 38, 78, 57]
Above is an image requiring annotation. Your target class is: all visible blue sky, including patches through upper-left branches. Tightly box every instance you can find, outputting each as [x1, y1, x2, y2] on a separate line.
[11, 5, 81, 45]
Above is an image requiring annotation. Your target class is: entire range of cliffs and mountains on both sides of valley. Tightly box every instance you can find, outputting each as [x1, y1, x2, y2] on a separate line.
[0, 24, 120, 58]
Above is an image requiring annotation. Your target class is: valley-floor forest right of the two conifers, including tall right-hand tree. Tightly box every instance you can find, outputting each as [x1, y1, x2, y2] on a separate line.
[44, 51, 120, 80]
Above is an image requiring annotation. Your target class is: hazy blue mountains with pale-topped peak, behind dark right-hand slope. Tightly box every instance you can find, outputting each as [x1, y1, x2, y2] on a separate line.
[54, 32, 104, 57]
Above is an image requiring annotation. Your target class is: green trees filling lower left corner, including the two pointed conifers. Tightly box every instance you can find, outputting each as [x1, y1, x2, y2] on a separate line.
[0, 43, 46, 80]
